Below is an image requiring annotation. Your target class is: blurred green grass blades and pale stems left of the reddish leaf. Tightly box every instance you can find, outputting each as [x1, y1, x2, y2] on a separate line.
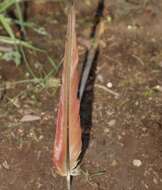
[0, 0, 61, 93]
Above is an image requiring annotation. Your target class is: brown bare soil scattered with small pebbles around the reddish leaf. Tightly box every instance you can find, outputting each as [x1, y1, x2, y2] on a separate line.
[0, 0, 162, 190]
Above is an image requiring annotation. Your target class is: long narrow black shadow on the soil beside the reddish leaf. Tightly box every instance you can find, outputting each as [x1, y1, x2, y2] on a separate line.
[80, 0, 104, 160]
